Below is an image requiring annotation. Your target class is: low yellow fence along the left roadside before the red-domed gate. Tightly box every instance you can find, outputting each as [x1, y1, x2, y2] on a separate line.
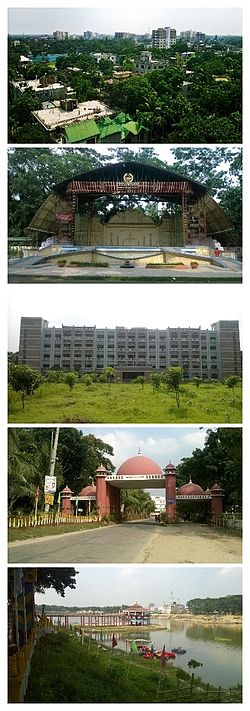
[8, 513, 98, 528]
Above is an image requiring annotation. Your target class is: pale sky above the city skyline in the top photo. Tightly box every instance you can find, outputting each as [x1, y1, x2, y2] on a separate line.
[9, 3, 242, 35]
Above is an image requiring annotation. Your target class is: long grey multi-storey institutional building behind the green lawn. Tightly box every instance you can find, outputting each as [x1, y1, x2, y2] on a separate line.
[18, 317, 241, 380]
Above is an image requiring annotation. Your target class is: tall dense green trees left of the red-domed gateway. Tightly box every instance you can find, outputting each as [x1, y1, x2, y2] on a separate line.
[8, 427, 114, 512]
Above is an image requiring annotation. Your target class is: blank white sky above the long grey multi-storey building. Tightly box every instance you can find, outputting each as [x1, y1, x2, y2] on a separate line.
[8, 284, 241, 351]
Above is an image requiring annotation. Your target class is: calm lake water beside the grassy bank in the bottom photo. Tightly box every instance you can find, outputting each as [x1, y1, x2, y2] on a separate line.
[61, 617, 242, 689]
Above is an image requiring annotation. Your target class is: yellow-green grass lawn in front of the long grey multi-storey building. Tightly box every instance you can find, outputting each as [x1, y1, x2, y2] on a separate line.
[9, 382, 242, 424]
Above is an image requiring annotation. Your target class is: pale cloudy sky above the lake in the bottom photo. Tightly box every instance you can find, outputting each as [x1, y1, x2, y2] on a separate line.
[36, 565, 242, 608]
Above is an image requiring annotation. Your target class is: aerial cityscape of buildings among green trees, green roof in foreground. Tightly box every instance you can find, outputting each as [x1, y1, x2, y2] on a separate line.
[8, 9, 242, 145]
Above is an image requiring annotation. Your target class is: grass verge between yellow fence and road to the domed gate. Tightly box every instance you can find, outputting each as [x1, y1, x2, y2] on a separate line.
[8, 522, 107, 543]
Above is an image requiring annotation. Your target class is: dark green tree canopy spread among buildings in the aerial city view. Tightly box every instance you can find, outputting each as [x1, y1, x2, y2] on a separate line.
[9, 37, 242, 143]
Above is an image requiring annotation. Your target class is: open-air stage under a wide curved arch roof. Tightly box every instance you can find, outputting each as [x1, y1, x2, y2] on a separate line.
[27, 161, 232, 259]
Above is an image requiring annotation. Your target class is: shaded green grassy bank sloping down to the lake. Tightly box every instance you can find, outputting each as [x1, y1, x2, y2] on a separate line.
[25, 631, 240, 704]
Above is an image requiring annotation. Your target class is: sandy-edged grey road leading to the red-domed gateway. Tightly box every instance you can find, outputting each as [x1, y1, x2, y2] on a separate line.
[9, 521, 241, 565]
